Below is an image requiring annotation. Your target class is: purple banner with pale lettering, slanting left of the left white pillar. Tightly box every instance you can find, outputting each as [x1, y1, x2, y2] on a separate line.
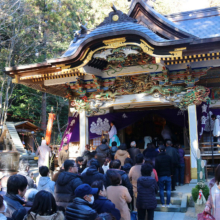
[59, 112, 79, 151]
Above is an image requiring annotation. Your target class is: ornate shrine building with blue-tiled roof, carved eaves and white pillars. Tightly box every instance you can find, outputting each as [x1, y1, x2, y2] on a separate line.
[6, 0, 220, 180]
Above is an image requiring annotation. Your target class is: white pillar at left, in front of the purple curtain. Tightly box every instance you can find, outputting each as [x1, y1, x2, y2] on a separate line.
[79, 111, 89, 155]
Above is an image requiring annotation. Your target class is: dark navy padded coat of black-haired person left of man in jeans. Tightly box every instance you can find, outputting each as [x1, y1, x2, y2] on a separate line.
[136, 176, 158, 209]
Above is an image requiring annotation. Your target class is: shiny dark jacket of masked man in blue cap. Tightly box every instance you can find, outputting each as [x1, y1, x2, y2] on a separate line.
[65, 197, 97, 220]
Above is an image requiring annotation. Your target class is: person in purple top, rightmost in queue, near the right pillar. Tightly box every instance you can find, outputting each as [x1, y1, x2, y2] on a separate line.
[175, 144, 185, 186]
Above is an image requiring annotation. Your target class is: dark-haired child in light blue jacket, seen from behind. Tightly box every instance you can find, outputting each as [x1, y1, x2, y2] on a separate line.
[37, 166, 55, 194]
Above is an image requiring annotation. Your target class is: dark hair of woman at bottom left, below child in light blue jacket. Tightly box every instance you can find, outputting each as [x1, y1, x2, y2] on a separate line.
[28, 190, 57, 216]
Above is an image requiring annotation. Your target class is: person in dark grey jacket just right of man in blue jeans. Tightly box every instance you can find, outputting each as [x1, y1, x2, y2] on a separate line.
[166, 140, 179, 191]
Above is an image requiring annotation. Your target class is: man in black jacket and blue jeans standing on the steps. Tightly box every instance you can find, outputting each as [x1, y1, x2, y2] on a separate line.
[155, 145, 173, 207]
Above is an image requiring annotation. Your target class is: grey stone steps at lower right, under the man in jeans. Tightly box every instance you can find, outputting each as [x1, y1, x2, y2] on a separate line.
[155, 191, 187, 212]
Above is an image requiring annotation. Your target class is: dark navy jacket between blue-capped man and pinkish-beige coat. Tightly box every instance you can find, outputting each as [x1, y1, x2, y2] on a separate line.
[92, 196, 121, 220]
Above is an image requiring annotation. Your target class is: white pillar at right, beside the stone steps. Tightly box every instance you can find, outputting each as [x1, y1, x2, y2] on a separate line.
[188, 105, 199, 183]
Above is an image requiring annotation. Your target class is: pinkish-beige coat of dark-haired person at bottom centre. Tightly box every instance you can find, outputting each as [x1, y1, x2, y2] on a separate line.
[106, 186, 132, 220]
